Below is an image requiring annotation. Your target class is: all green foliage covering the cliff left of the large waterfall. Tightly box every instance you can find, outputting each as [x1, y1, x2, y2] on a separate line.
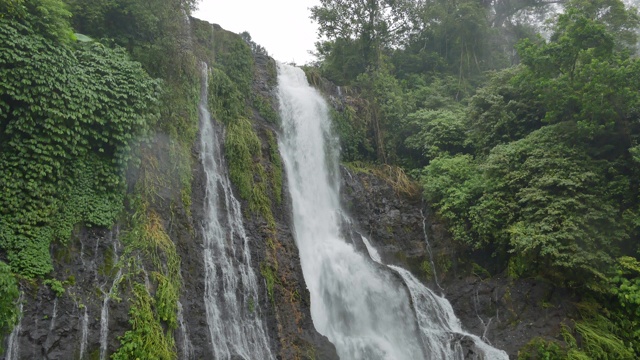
[0, 0, 282, 359]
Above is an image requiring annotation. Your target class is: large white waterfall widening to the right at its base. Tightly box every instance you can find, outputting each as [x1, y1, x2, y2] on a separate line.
[278, 64, 508, 360]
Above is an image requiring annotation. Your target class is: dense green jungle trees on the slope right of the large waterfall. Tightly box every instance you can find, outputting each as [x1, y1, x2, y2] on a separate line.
[306, 0, 640, 359]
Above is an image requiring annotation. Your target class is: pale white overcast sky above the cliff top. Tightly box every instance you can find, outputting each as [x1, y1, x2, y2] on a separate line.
[193, 0, 319, 65]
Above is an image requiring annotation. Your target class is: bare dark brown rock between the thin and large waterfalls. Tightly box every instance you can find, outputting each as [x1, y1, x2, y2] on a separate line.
[243, 54, 338, 360]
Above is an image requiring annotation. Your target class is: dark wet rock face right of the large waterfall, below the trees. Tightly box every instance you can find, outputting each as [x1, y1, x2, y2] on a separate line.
[341, 167, 575, 359]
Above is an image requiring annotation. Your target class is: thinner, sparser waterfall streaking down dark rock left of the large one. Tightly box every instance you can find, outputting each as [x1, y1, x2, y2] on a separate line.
[199, 66, 274, 360]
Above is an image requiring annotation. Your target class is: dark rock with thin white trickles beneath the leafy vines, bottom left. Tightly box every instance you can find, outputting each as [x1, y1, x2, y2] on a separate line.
[5, 229, 129, 360]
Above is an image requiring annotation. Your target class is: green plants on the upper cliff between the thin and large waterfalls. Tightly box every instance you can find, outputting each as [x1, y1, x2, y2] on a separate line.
[199, 25, 282, 231]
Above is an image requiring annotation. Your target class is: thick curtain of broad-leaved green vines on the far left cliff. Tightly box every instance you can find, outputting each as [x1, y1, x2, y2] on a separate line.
[0, 0, 158, 277]
